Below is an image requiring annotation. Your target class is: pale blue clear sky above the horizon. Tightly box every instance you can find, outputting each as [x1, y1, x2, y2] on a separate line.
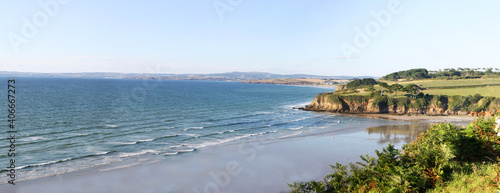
[0, 0, 500, 76]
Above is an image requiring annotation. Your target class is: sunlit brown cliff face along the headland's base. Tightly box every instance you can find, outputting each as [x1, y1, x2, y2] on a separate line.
[305, 94, 500, 116]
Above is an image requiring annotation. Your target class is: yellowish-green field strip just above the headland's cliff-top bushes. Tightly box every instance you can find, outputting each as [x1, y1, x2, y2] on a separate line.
[422, 86, 500, 97]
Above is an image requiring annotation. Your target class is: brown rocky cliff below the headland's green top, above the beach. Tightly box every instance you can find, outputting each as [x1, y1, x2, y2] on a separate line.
[305, 93, 500, 116]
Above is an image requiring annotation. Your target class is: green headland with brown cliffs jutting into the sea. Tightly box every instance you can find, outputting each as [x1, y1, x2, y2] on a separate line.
[305, 69, 500, 116]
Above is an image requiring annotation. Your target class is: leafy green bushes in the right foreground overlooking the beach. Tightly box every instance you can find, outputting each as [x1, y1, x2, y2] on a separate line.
[289, 118, 500, 193]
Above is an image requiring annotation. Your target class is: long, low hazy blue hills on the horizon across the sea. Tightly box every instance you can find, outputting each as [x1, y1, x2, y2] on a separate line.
[0, 71, 377, 81]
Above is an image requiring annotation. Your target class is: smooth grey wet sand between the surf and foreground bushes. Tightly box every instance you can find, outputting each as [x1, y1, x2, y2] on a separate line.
[0, 123, 429, 193]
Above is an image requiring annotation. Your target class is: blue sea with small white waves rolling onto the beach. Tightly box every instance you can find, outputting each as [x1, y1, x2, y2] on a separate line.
[0, 77, 400, 184]
